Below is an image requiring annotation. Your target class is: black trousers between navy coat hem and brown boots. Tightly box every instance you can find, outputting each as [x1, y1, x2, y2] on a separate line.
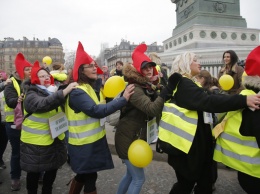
[75, 172, 97, 193]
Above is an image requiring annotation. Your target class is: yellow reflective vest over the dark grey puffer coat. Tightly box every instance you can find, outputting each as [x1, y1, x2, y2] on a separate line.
[21, 108, 65, 145]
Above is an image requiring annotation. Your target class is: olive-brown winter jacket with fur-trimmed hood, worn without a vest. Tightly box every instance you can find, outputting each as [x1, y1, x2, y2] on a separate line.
[115, 65, 164, 159]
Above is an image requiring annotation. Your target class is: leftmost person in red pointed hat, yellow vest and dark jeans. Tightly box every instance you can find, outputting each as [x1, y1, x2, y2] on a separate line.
[4, 53, 32, 191]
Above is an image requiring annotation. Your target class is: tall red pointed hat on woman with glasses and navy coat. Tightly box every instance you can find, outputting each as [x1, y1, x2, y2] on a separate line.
[73, 41, 103, 81]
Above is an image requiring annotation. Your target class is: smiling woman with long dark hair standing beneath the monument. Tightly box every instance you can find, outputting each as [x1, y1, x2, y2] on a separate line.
[218, 50, 244, 94]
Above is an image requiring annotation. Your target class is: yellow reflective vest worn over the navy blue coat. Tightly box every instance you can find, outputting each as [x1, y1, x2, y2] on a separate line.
[65, 84, 106, 145]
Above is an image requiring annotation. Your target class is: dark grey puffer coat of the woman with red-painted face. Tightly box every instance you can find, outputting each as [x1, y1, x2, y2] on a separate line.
[20, 83, 67, 172]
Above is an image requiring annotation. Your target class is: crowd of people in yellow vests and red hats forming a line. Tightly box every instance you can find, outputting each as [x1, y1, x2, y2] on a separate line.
[0, 42, 260, 194]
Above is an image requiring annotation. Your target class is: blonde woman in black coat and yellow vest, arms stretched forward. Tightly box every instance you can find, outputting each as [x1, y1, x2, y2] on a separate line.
[158, 52, 260, 194]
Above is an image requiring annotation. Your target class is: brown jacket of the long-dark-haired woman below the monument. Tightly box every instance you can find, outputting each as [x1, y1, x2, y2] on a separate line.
[218, 64, 244, 94]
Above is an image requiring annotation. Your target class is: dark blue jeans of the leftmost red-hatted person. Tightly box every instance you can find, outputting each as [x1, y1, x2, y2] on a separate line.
[5, 122, 21, 180]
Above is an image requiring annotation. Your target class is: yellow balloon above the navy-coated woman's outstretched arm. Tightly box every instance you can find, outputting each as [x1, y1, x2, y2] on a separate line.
[104, 76, 126, 98]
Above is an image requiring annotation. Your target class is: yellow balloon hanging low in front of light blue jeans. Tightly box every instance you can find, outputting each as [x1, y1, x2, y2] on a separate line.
[128, 139, 153, 168]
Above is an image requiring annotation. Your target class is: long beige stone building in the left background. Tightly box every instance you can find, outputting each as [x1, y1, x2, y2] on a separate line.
[0, 37, 64, 74]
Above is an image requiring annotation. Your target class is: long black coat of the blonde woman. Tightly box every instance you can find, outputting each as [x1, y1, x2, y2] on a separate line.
[168, 77, 247, 181]
